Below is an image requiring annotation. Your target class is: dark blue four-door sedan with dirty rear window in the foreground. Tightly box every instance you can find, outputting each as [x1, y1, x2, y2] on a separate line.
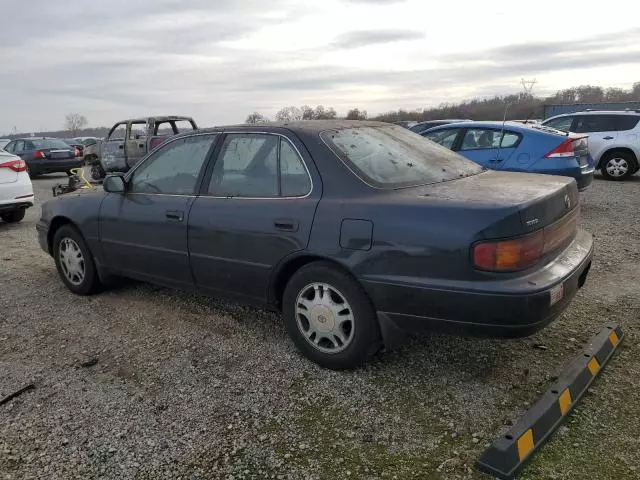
[37, 121, 592, 369]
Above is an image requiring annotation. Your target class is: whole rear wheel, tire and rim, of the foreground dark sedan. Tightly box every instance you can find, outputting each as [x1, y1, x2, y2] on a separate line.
[283, 262, 380, 370]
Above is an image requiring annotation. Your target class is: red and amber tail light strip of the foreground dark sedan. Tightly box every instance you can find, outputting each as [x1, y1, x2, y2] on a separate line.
[473, 208, 579, 272]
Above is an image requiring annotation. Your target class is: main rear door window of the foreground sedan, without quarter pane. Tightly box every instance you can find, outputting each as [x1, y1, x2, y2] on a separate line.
[208, 133, 279, 197]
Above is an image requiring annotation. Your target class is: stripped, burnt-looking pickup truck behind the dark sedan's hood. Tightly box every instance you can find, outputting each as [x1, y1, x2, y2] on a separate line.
[87, 115, 198, 180]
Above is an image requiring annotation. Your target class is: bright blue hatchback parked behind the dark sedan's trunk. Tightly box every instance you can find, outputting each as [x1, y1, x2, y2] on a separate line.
[421, 122, 595, 191]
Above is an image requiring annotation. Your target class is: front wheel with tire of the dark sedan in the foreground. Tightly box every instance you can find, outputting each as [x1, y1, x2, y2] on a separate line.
[53, 225, 101, 295]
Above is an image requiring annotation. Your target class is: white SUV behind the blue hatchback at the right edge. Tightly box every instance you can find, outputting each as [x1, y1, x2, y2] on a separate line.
[542, 110, 640, 180]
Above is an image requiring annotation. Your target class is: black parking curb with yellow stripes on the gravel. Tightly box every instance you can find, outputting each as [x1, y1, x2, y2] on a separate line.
[476, 325, 624, 479]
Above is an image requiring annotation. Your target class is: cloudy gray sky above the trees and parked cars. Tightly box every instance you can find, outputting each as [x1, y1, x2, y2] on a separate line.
[0, 0, 640, 133]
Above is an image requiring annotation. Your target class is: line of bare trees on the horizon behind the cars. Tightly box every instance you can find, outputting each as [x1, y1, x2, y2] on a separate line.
[245, 82, 640, 124]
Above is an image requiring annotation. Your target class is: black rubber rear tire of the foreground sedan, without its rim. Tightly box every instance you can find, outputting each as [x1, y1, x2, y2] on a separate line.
[282, 262, 381, 370]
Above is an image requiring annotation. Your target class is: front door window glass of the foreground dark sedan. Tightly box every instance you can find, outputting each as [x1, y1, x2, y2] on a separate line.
[129, 135, 215, 195]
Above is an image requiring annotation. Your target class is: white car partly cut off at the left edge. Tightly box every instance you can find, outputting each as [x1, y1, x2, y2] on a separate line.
[0, 150, 34, 223]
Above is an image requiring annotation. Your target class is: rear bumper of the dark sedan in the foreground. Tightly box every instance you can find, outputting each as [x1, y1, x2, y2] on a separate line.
[363, 230, 593, 337]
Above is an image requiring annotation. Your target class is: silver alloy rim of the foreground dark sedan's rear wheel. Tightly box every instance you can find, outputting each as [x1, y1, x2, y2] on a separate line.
[296, 283, 355, 353]
